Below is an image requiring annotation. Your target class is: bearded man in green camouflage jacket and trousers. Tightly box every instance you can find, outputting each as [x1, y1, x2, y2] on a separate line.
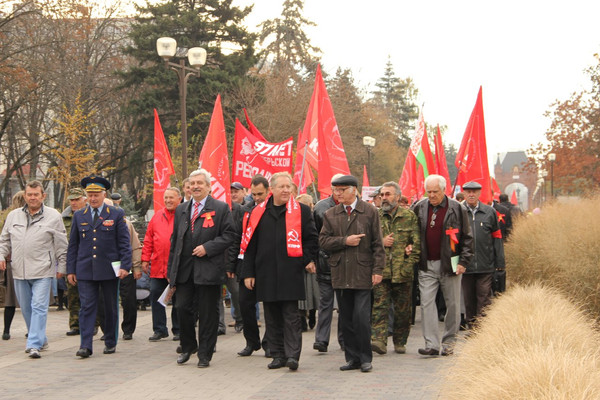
[371, 182, 421, 354]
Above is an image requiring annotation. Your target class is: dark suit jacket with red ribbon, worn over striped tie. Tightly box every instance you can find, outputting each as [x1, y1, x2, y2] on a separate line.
[167, 196, 236, 286]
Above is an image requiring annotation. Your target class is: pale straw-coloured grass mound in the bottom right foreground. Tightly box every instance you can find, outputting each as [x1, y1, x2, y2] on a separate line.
[440, 283, 600, 400]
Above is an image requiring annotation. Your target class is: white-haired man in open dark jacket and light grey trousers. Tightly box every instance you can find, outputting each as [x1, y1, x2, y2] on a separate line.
[413, 175, 473, 356]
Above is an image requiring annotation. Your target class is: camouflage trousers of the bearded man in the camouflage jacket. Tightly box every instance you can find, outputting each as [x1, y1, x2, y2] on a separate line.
[371, 279, 413, 346]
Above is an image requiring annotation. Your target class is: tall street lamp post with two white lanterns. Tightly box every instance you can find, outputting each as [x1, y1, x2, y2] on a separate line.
[156, 37, 206, 178]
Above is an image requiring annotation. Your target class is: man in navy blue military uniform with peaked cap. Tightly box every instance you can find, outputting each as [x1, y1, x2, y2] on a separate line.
[67, 176, 132, 358]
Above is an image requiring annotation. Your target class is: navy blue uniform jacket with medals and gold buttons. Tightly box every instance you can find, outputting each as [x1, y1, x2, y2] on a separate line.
[67, 204, 131, 281]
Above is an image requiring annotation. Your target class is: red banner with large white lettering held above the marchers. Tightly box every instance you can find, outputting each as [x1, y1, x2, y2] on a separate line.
[232, 120, 294, 188]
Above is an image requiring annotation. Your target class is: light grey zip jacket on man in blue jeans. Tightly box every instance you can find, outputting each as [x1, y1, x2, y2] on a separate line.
[0, 205, 67, 279]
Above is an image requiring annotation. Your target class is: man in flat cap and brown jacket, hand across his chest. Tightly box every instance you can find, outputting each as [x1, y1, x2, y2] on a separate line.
[319, 175, 385, 372]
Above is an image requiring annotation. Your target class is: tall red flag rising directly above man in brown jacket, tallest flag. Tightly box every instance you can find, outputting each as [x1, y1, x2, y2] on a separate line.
[303, 65, 350, 199]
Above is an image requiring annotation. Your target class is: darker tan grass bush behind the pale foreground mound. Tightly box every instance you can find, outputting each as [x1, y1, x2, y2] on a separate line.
[505, 197, 600, 320]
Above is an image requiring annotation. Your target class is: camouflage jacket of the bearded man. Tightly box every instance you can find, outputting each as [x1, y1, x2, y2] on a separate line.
[379, 207, 421, 283]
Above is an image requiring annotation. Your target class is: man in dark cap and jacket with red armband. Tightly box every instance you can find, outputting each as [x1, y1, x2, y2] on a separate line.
[462, 182, 504, 325]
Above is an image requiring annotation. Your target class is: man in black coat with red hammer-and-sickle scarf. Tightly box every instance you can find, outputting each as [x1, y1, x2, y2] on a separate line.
[241, 172, 318, 371]
